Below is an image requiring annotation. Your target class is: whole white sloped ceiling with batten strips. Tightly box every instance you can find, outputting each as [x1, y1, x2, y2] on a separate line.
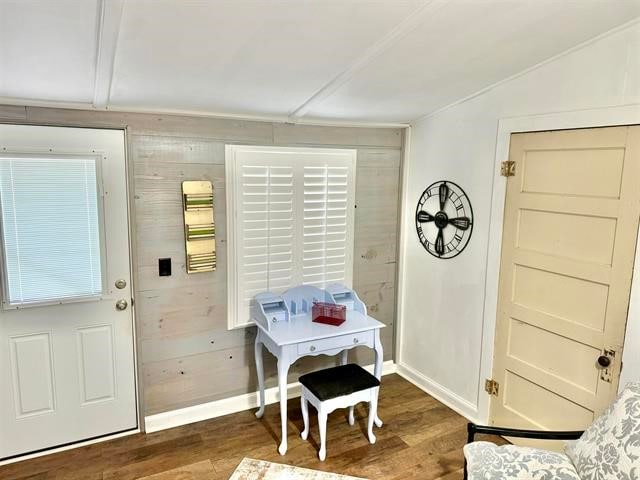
[0, 0, 640, 123]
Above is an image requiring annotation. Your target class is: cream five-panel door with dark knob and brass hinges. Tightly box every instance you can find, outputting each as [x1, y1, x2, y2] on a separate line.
[490, 126, 640, 438]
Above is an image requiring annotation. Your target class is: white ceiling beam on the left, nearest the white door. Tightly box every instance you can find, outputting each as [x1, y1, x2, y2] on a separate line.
[93, 0, 124, 108]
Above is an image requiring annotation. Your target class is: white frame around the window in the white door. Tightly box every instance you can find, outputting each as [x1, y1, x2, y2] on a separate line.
[0, 149, 108, 311]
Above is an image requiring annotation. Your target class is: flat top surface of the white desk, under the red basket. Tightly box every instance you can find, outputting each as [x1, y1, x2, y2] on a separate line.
[258, 310, 386, 346]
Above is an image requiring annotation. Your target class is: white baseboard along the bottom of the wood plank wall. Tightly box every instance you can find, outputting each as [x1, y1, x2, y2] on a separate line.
[144, 360, 396, 433]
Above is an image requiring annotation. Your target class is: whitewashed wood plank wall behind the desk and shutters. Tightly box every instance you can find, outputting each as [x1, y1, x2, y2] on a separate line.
[0, 106, 403, 415]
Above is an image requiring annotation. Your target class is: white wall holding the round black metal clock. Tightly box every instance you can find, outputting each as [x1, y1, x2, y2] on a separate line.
[398, 23, 640, 421]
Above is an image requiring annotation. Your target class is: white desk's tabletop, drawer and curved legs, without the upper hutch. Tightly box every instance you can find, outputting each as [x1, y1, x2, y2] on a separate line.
[255, 310, 385, 455]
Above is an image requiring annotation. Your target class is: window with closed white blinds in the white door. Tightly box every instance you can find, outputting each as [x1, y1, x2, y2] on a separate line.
[0, 155, 103, 308]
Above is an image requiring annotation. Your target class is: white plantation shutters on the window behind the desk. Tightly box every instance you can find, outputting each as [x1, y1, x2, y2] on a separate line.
[225, 145, 356, 328]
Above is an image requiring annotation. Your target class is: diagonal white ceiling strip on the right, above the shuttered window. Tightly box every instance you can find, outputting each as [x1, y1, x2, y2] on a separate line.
[289, 0, 446, 122]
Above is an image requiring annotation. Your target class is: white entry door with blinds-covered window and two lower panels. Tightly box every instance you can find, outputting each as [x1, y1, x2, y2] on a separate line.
[0, 125, 137, 458]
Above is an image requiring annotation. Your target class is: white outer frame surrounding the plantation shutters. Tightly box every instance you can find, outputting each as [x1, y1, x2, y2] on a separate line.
[225, 145, 357, 330]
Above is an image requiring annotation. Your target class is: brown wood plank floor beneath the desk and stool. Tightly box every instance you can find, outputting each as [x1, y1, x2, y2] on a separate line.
[0, 375, 502, 480]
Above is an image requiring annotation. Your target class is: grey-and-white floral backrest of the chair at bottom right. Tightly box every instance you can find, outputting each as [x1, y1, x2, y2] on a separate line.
[565, 383, 640, 480]
